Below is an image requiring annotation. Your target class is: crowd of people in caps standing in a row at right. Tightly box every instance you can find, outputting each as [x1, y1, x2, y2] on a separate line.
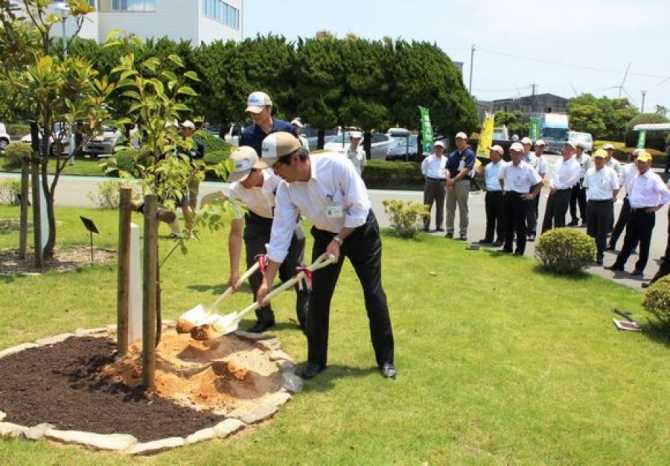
[422, 133, 670, 280]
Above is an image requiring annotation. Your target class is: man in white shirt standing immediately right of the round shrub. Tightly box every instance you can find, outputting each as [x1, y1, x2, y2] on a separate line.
[583, 149, 619, 265]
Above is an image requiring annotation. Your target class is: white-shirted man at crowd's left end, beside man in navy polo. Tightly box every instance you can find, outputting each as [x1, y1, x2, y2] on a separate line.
[421, 141, 447, 231]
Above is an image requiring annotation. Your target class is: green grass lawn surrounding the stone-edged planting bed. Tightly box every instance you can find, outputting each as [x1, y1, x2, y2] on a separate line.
[0, 206, 670, 465]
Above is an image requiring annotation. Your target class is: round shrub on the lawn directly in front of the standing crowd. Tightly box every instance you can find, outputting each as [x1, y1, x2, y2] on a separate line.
[535, 228, 596, 274]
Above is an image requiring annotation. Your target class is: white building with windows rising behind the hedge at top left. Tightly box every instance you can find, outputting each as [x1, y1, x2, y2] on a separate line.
[54, 0, 243, 46]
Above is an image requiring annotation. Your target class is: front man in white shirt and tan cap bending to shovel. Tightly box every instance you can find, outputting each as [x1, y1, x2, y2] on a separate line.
[257, 133, 397, 379]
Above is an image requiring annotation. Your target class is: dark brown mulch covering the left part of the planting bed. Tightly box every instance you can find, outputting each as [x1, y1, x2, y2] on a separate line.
[0, 337, 224, 442]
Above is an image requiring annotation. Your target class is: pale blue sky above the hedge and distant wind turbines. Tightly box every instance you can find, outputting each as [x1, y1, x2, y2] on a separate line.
[242, 0, 670, 112]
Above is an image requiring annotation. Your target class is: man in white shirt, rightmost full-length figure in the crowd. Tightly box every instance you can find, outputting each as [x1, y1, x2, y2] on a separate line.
[605, 152, 670, 277]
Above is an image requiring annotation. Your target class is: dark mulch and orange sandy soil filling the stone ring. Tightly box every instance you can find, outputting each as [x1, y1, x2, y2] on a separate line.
[0, 332, 282, 442]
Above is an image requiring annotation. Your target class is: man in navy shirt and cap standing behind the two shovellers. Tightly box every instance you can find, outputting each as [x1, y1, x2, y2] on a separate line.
[240, 91, 298, 157]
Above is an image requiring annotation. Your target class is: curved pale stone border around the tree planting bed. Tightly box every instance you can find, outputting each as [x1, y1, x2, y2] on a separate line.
[0, 321, 303, 455]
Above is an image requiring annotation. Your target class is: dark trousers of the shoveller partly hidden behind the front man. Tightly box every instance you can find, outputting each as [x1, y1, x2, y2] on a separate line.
[244, 211, 310, 327]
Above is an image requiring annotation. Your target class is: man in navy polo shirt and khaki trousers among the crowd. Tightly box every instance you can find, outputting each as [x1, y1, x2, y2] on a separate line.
[446, 132, 477, 241]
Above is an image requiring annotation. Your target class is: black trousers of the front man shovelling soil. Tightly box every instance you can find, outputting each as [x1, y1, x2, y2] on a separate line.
[306, 210, 394, 366]
